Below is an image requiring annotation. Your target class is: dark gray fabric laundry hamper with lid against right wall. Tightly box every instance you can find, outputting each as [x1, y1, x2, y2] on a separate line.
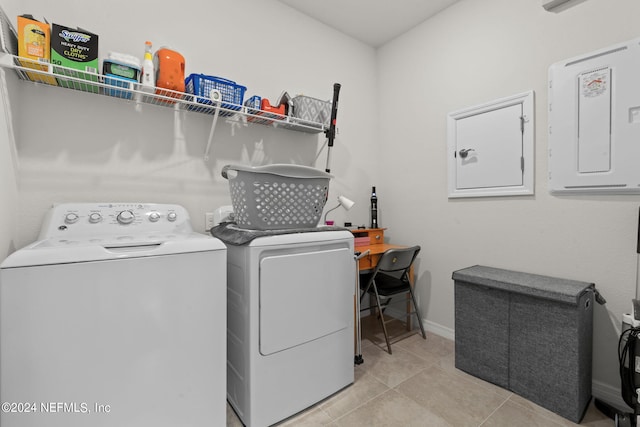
[453, 265, 594, 423]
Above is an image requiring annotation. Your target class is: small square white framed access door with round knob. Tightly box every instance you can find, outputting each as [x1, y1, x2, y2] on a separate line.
[448, 92, 533, 197]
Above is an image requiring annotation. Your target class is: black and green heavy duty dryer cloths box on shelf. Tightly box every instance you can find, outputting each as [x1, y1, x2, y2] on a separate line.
[51, 24, 100, 93]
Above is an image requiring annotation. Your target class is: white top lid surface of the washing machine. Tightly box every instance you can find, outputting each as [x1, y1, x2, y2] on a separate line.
[0, 233, 227, 268]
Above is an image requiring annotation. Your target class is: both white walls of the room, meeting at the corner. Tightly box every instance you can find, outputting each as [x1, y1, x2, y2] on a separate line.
[0, 0, 640, 408]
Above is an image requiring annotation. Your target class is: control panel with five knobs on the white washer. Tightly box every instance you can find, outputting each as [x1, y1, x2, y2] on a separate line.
[39, 203, 193, 240]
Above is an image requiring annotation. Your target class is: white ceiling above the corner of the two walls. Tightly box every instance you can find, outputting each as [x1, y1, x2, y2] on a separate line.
[278, 0, 459, 47]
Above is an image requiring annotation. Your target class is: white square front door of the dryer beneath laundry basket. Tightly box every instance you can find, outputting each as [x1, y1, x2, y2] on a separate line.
[260, 248, 355, 356]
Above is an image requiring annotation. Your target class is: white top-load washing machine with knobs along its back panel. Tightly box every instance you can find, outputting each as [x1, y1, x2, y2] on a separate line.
[0, 203, 226, 427]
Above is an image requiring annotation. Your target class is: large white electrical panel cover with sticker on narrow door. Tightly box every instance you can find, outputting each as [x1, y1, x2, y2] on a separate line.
[549, 39, 640, 193]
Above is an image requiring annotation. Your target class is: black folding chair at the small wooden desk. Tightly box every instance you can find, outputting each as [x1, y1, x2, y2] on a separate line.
[360, 246, 427, 354]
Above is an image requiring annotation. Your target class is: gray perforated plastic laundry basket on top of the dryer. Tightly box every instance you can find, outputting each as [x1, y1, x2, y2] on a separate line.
[222, 164, 332, 230]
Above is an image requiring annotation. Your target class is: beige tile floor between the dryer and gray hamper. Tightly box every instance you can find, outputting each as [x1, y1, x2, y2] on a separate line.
[227, 317, 614, 427]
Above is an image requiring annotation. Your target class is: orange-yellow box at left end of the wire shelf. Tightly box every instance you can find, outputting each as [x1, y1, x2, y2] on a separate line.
[18, 15, 57, 85]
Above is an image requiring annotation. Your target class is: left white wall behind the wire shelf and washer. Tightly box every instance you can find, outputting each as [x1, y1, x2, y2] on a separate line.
[0, 0, 376, 251]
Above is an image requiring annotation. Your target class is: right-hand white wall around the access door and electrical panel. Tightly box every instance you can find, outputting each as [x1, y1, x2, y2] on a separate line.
[377, 0, 640, 404]
